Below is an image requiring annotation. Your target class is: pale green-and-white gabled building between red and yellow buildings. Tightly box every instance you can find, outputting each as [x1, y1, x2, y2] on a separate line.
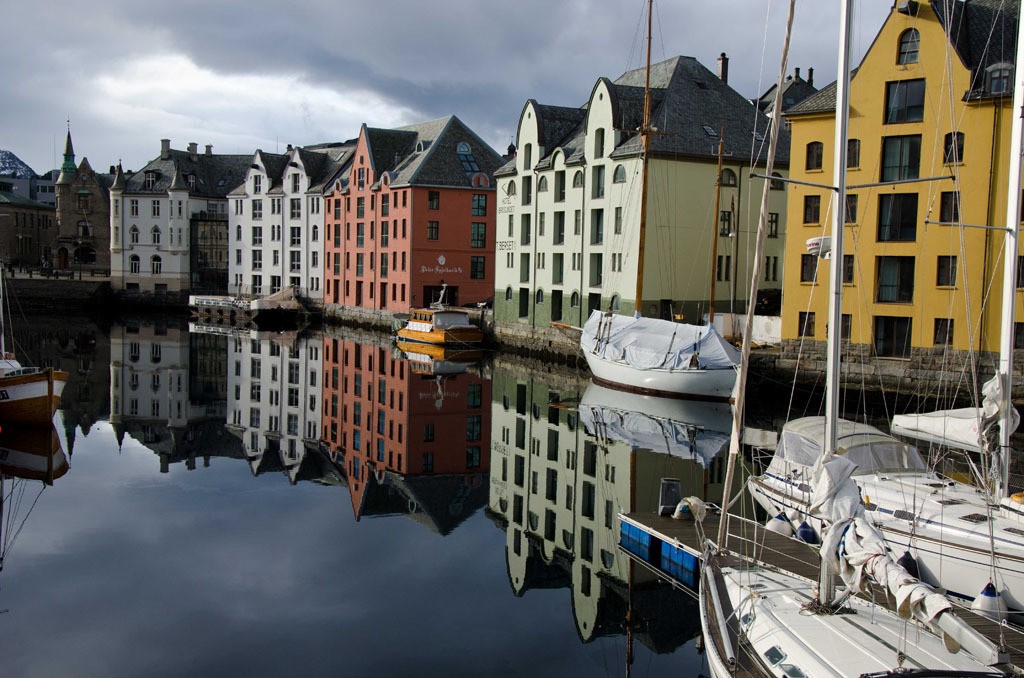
[495, 55, 788, 346]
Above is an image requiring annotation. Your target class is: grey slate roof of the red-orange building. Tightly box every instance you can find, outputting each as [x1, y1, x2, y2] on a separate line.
[365, 116, 505, 187]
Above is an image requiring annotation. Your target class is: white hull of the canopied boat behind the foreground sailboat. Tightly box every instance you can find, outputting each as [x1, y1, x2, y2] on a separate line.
[749, 473, 1024, 615]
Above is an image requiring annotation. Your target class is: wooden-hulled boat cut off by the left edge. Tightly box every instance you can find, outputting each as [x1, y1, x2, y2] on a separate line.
[0, 273, 68, 426]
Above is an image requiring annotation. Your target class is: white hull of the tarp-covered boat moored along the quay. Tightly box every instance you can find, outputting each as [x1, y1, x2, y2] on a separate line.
[585, 352, 736, 401]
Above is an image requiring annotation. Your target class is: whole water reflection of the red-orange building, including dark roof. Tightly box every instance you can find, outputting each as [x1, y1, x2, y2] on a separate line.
[322, 333, 490, 535]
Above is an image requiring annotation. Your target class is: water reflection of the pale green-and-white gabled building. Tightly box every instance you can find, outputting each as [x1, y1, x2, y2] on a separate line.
[489, 366, 721, 651]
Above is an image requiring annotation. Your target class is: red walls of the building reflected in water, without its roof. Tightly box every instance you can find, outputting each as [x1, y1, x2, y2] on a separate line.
[323, 336, 490, 516]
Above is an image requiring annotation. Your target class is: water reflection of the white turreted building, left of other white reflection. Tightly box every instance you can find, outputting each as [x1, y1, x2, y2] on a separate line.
[110, 317, 243, 473]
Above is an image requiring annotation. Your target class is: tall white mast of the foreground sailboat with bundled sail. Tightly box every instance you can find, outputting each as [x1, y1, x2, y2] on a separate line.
[818, 0, 853, 607]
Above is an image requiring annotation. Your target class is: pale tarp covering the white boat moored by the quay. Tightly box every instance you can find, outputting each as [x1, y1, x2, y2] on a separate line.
[580, 310, 739, 370]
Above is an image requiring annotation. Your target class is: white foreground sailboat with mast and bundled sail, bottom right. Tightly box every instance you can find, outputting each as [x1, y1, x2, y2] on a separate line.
[699, 0, 1007, 678]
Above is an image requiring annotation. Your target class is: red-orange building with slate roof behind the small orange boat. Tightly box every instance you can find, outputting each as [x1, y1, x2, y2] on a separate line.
[325, 116, 504, 311]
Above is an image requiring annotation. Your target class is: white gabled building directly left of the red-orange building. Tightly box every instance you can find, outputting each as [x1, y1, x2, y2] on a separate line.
[228, 142, 355, 303]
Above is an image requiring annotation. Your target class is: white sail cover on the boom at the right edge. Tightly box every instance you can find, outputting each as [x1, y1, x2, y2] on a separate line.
[891, 377, 1020, 452]
